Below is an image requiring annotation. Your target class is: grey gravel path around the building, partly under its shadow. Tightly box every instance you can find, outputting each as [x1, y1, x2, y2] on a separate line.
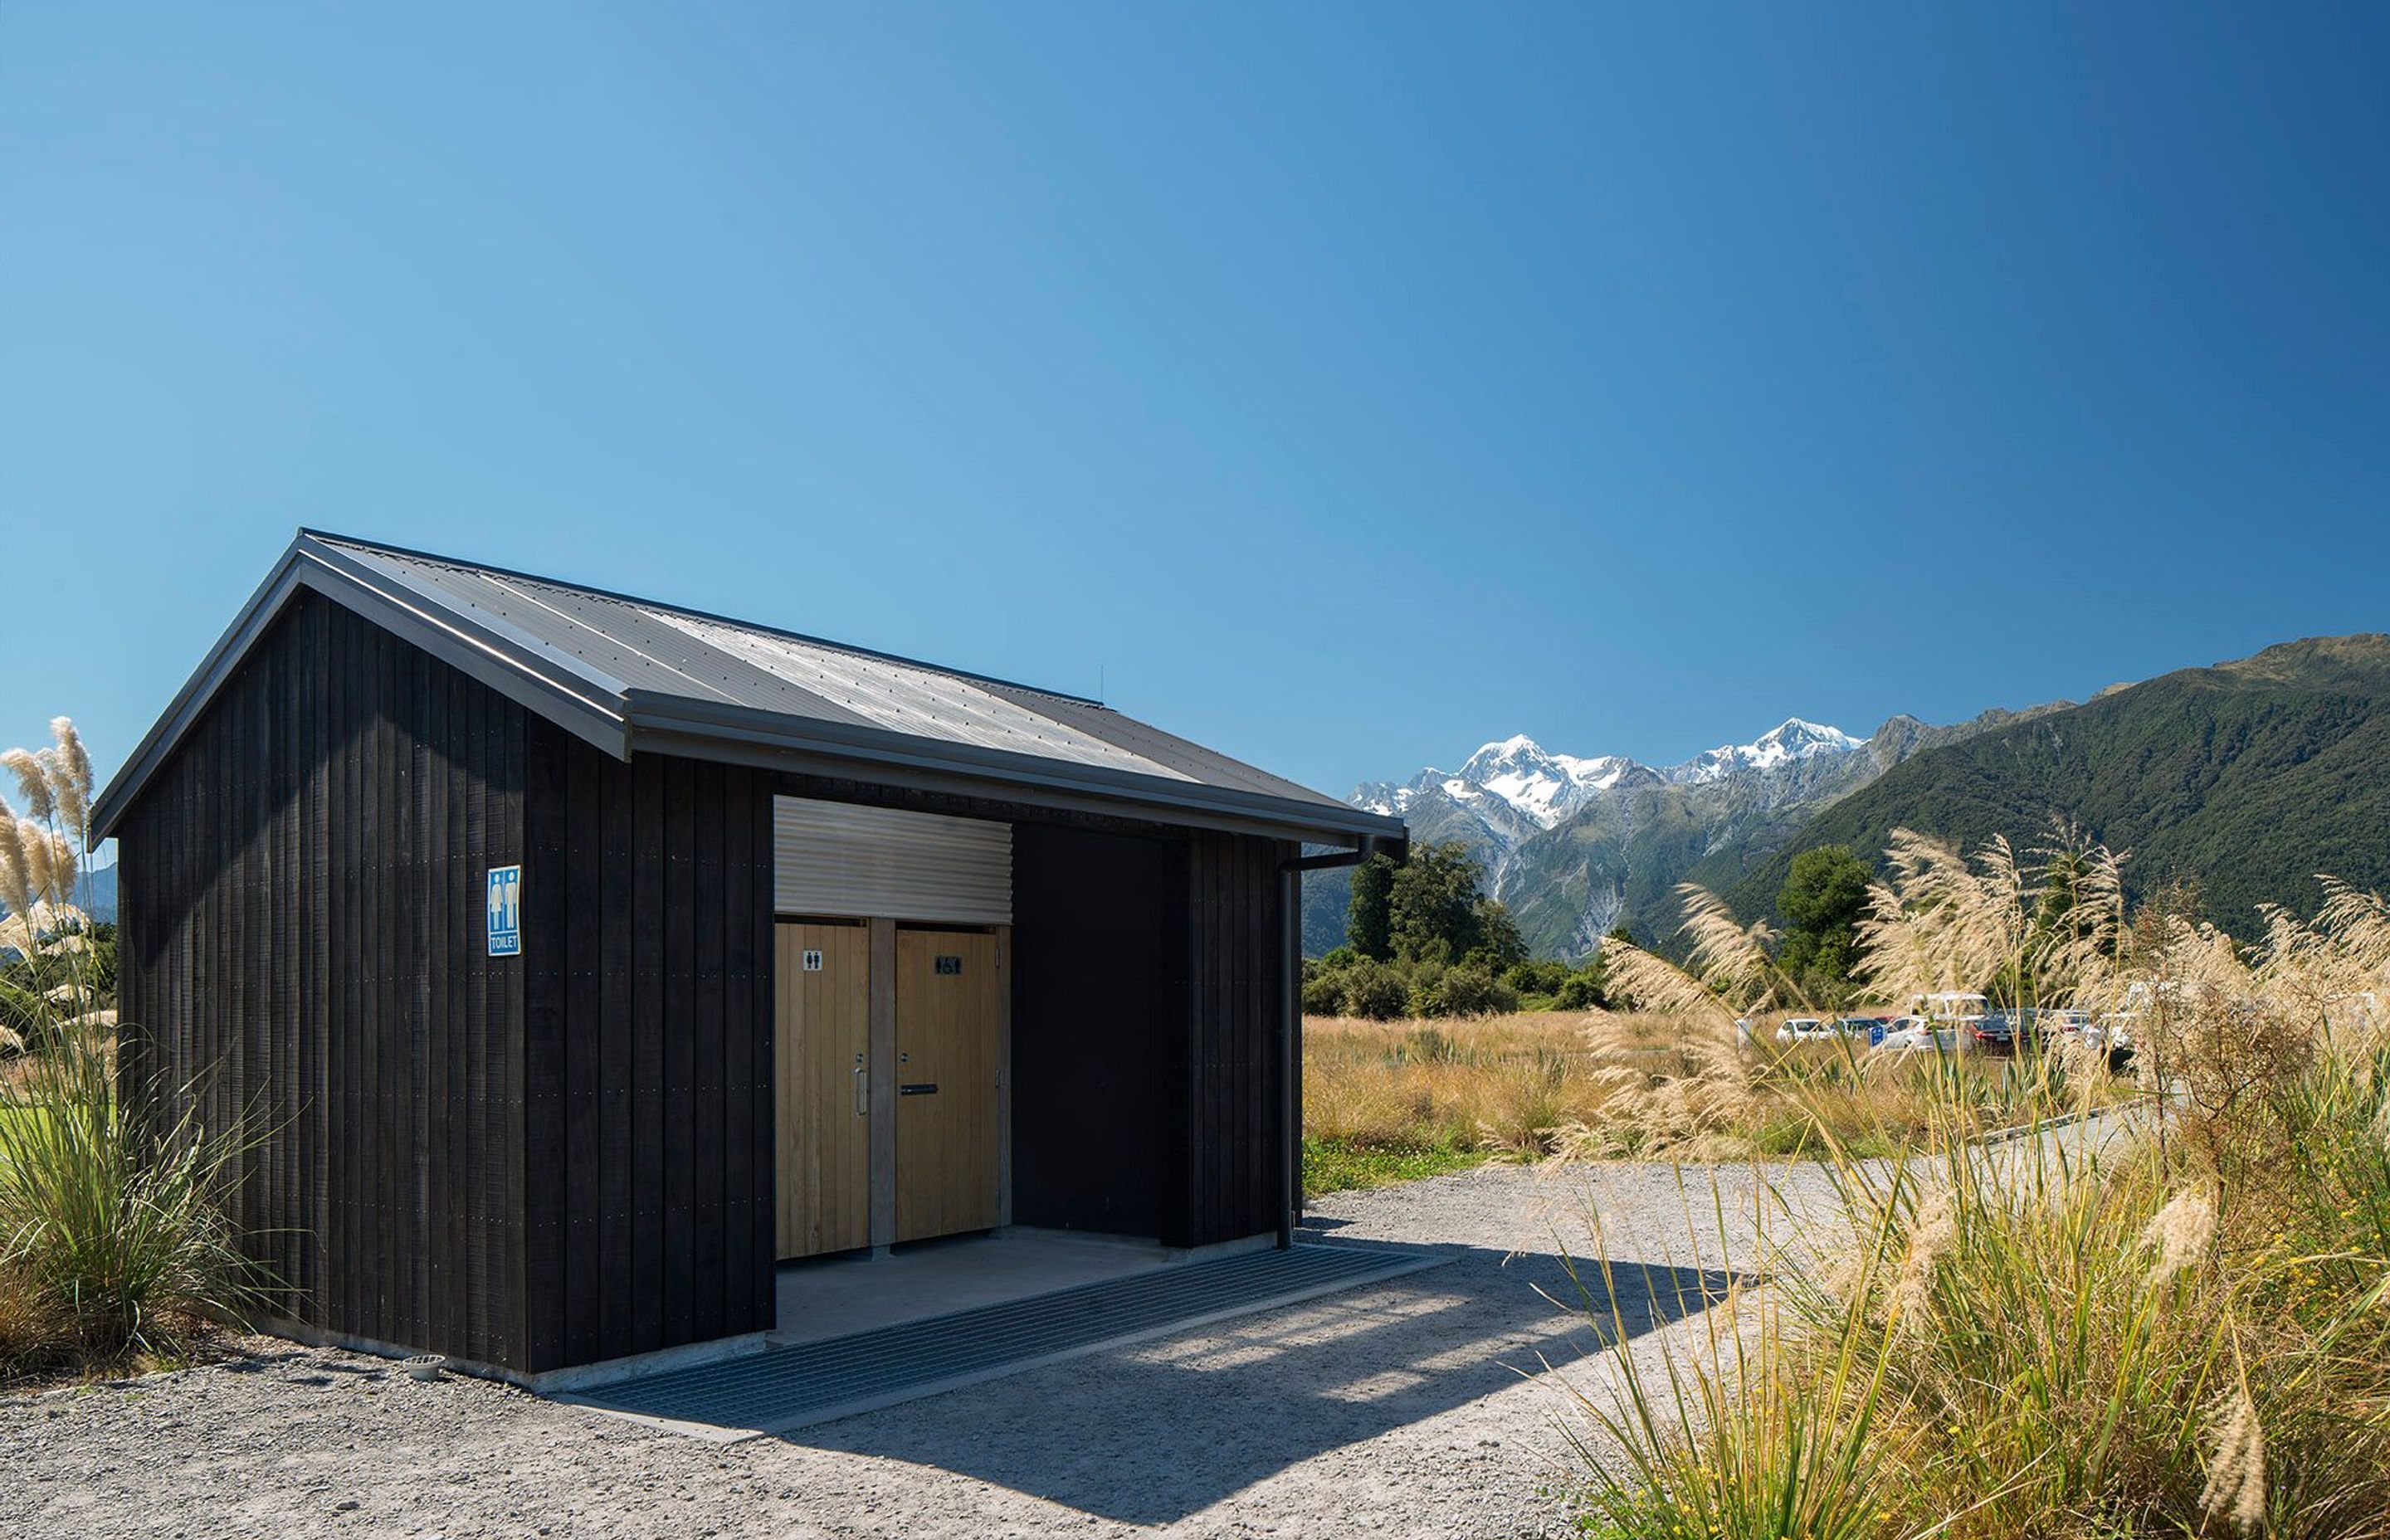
[0, 1167, 1816, 1538]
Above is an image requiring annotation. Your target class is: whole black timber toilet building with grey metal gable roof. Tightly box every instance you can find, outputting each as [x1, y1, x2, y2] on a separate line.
[95, 531, 1405, 1377]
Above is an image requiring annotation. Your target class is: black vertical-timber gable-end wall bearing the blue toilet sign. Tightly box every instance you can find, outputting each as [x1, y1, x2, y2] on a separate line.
[117, 593, 526, 1366]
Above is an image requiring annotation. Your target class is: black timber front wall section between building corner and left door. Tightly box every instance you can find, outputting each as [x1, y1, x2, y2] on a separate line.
[521, 719, 777, 1370]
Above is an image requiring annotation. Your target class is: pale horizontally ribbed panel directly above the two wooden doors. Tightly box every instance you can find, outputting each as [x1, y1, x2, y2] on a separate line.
[772, 797, 1013, 925]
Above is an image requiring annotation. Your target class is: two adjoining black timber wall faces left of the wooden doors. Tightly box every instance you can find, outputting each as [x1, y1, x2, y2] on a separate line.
[117, 596, 772, 1370]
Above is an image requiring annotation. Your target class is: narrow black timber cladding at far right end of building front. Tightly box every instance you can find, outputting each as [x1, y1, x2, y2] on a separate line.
[1185, 830, 1300, 1246]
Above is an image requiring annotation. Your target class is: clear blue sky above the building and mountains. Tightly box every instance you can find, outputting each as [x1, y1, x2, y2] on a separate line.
[0, 5, 2390, 808]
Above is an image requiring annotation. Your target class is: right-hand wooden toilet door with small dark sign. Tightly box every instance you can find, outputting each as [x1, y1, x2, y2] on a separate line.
[896, 930, 1004, 1241]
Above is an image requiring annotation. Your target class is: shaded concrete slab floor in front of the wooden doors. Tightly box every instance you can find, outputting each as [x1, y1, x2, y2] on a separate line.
[769, 1226, 1181, 1347]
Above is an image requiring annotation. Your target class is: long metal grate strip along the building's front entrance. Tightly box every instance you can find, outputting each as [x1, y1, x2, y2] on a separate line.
[559, 1246, 1448, 1437]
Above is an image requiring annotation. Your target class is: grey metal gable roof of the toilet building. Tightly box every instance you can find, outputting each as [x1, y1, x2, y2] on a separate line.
[93, 529, 1405, 844]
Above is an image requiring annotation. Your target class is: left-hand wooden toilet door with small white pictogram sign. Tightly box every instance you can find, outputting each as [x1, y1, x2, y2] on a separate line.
[772, 921, 872, 1258]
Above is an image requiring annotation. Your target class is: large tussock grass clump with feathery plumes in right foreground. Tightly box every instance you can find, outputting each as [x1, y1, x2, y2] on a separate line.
[1580, 837, 2390, 1540]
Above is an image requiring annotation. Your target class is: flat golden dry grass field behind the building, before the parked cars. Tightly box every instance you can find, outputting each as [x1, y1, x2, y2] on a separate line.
[1303, 1011, 2124, 1193]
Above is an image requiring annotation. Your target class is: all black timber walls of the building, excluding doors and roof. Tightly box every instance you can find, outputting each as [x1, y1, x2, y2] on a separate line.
[117, 593, 1295, 1372]
